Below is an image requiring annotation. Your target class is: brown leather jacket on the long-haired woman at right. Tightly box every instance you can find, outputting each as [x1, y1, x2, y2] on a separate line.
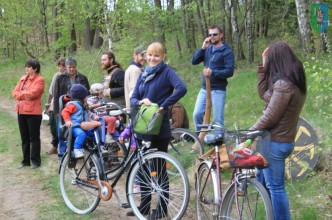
[250, 65, 306, 143]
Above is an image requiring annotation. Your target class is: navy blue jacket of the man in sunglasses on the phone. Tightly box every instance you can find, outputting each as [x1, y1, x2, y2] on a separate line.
[191, 43, 235, 90]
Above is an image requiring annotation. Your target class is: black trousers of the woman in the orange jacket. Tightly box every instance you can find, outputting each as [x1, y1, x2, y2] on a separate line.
[17, 114, 42, 166]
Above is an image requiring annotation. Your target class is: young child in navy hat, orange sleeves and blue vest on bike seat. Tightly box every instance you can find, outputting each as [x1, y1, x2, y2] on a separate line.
[61, 84, 93, 158]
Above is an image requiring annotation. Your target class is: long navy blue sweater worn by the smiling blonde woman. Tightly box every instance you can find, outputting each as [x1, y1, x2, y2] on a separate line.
[130, 64, 187, 140]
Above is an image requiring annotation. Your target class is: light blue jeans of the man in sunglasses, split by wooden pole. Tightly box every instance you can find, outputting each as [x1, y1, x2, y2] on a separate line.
[193, 89, 226, 131]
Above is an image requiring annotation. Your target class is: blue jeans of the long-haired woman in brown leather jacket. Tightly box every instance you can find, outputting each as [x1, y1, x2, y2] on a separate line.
[260, 142, 295, 220]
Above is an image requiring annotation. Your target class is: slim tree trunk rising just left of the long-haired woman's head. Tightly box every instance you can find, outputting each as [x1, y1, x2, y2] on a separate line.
[246, 0, 255, 63]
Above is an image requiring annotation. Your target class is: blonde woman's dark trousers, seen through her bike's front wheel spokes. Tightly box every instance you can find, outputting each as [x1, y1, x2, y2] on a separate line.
[138, 139, 170, 213]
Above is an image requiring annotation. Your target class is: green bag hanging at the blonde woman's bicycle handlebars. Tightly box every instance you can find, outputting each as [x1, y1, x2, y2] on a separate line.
[132, 103, 164, 135]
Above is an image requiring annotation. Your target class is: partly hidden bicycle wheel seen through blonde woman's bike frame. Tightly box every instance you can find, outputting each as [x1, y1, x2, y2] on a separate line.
[103, 141, 127, 180]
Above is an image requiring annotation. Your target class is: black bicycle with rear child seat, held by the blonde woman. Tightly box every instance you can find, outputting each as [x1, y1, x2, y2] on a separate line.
[60, 102, 189, 219]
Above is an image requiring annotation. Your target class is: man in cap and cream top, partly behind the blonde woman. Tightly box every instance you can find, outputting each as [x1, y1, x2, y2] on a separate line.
[125, 45, 146, 108]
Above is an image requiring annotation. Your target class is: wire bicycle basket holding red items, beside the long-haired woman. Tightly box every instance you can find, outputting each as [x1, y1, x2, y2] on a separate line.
[224, 130, 271, 168]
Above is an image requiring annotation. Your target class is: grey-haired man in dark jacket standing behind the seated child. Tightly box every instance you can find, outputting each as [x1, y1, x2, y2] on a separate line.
[53, 57, 90, 158]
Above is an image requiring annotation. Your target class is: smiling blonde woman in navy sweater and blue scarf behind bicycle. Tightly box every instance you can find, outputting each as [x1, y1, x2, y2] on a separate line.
[127, 42, 187, 219]
